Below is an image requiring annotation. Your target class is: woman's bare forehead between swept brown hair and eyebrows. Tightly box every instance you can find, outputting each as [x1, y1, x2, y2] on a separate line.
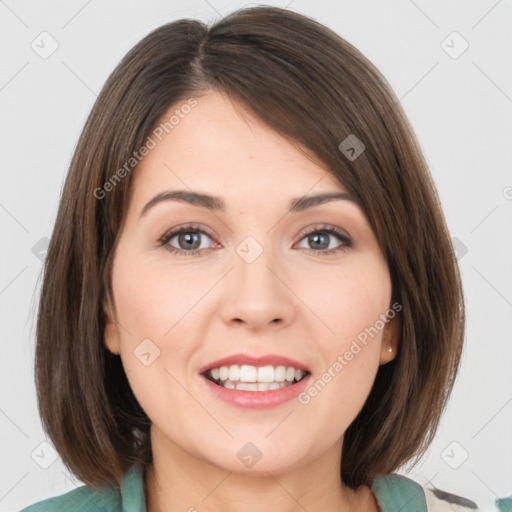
[133, 91, 345, 208]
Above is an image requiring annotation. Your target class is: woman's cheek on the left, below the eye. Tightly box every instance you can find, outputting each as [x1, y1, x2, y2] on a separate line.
[112, 251, 197, 423]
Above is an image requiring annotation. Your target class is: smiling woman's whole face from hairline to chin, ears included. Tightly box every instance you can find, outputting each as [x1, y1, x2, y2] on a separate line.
[105, 92, 396, 473]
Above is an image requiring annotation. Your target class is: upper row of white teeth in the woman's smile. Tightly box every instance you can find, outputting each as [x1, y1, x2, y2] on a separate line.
[207, 364, 306, 382]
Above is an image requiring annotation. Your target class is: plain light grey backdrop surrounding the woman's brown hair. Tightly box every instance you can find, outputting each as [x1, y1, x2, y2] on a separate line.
[0, 0, 512, 511]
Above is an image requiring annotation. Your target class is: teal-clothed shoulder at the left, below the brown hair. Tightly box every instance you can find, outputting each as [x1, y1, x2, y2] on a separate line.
[21, 485, 121, 512]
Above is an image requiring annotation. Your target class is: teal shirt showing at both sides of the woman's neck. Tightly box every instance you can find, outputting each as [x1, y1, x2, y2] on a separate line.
[21, 466, 427, 512]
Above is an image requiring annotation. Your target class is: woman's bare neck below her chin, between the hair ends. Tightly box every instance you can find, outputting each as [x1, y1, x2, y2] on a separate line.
[144, 428, 379, 512]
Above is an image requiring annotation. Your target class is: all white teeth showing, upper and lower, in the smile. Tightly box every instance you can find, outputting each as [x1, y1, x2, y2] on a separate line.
[207, 364, 307, 391]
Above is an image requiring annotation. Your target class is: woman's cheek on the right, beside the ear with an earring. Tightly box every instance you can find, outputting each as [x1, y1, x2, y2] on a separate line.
[294, 260, 391, 437]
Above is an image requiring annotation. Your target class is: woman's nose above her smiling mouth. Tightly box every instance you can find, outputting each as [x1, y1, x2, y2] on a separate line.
[221, 244, 297, 332]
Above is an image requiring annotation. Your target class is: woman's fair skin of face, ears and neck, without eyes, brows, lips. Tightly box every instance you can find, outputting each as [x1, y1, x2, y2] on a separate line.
[104, 91, 397, 512]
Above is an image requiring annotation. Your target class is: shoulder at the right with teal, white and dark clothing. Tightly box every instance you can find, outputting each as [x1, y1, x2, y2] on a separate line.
[372, 474, 479, 512]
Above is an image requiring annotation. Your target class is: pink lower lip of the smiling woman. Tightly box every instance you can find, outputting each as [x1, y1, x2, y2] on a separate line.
[200, 374, 311, 409]
